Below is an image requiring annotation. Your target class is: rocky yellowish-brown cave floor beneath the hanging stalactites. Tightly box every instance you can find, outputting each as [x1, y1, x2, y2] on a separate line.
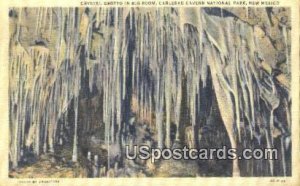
[9, 125, 231, 178]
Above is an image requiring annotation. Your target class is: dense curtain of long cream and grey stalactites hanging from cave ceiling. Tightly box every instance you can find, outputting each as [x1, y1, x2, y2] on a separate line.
[9, 7, 291, 176]
